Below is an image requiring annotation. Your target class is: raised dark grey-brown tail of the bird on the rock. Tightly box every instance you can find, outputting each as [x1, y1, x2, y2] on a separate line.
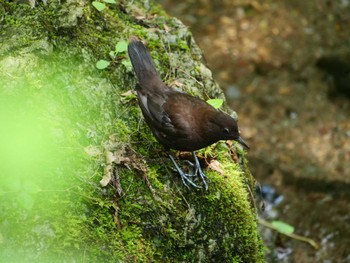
[128, 37, 161, 88]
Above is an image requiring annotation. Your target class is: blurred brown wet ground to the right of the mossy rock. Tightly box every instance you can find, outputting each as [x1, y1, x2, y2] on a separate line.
[159, 0, 350, 262]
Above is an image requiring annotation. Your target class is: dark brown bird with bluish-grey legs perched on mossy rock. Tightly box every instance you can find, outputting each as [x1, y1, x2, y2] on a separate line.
[128, 37, 249, 190]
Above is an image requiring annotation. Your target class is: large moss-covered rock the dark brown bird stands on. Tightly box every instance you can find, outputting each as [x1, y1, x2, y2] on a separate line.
[0, 0, 264, 262]
